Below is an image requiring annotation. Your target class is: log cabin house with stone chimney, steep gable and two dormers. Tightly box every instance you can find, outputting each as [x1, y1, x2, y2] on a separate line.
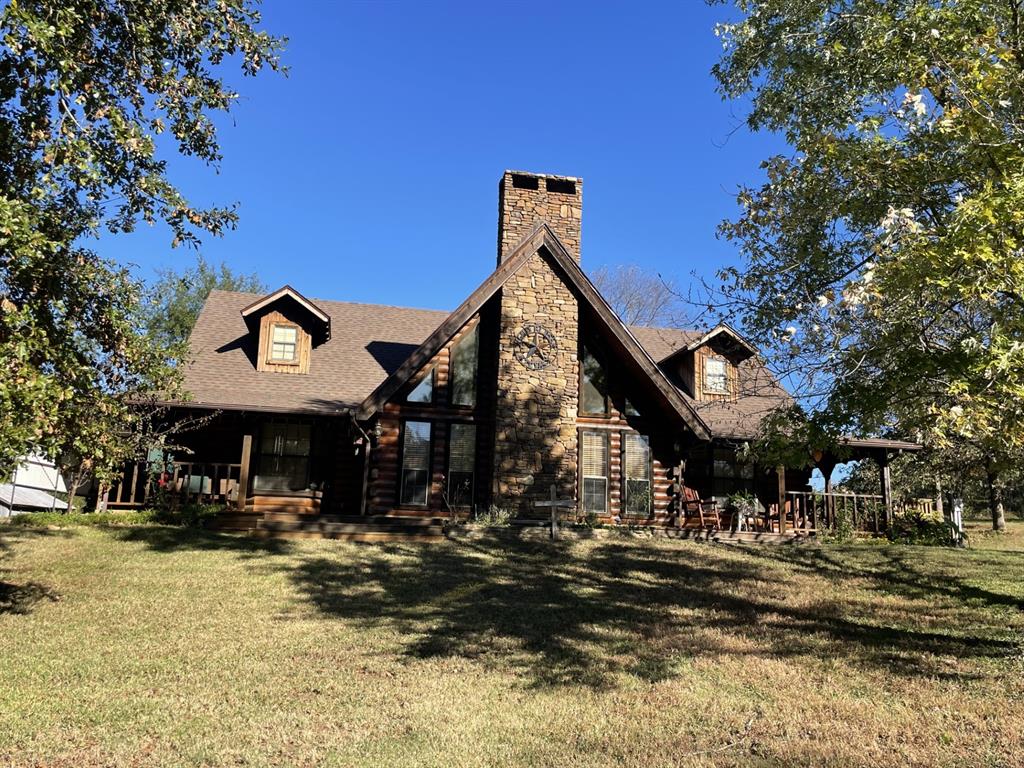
[116, 171, 911, 534]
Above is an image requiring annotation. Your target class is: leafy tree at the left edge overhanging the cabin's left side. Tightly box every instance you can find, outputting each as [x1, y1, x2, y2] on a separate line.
[0, 0, 281, 475]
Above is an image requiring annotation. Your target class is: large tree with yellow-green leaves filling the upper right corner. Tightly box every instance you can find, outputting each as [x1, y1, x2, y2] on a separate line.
[714, 0, 1024, 526]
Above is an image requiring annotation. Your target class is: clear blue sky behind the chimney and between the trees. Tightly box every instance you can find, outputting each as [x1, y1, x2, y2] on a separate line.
[100, 0, 780, 309]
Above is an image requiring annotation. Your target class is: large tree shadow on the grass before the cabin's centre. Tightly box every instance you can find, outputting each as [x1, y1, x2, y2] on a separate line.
[280, 540, 1016, 688]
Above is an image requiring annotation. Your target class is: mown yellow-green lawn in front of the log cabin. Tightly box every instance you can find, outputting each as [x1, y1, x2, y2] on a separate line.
[0, 522, 1024, 767]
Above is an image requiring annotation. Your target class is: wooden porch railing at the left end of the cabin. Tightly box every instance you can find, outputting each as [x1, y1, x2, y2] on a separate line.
[104, 461, 242, 509]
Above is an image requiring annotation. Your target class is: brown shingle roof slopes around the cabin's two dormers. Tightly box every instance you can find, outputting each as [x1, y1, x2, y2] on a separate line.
[185, 291, 788, 438]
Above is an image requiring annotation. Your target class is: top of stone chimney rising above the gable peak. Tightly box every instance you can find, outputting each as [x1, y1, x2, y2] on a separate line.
[498, 171, 583, 264]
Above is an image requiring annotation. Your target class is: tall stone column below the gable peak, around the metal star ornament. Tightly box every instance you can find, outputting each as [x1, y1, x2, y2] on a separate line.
[494, 254, 580, 517]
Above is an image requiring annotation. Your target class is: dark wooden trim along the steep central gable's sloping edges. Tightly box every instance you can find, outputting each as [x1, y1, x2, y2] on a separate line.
[356, 221, 712, 439]
